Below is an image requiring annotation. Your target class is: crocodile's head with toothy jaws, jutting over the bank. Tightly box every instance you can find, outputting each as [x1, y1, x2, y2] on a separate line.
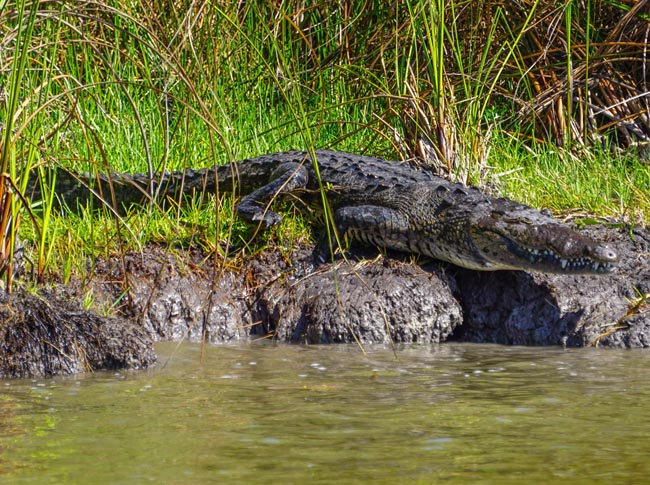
[470, 205, 618, 274]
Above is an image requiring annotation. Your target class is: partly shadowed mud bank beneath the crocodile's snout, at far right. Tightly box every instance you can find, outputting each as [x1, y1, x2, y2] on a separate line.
[454, 227, 650, 348]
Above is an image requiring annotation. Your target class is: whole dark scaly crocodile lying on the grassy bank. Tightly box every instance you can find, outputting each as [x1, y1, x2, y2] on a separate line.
[27, 150, 618, 274]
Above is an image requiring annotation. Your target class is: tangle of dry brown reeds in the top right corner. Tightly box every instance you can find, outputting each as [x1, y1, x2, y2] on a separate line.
[513, 1, 650, 146]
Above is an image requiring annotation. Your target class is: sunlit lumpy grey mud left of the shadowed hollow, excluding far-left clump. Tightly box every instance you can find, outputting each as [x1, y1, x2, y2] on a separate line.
[87, 247, 461, 344]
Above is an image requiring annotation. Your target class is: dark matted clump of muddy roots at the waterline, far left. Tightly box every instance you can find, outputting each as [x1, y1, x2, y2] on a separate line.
[0, 289, 156, 378]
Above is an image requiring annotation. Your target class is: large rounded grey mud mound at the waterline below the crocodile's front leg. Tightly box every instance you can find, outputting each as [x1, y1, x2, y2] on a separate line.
[250, 253, 462, 344]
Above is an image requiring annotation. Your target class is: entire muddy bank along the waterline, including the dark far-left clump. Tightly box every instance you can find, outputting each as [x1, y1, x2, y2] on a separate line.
[0, 223, 650, 377]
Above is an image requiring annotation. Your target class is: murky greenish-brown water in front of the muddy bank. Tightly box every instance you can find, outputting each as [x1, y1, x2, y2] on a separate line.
[0, 344, 650, 484]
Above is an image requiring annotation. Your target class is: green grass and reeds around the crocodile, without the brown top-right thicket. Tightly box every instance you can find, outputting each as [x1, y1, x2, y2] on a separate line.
[0, 0, 650, 286]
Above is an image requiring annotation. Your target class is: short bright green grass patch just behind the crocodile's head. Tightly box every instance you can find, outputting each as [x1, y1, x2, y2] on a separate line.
[489, 134, 650, 223]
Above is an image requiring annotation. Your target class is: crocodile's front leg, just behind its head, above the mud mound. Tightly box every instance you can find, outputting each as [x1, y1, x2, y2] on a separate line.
[316, 205, 410, 262]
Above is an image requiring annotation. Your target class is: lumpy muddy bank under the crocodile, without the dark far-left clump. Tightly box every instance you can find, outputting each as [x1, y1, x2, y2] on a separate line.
[95, 221, 650, 347]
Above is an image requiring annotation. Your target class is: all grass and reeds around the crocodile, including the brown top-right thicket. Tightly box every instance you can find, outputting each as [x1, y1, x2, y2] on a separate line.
[0, 0, 650, 289]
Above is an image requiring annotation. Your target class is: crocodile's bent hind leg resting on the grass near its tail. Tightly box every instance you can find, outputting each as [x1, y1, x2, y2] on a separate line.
[237, 162, 309, 228]
